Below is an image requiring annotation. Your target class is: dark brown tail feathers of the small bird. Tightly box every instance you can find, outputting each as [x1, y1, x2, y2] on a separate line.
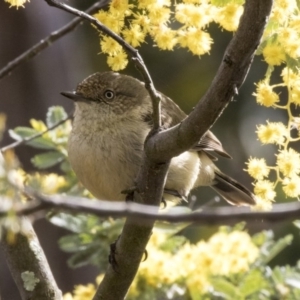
[211, 170, 256, 206]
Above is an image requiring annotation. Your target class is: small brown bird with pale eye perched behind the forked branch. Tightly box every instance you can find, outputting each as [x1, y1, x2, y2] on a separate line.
[62, 72, 255, 205]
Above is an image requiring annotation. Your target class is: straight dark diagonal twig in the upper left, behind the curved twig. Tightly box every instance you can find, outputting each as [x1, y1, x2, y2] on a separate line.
[0, 0, 109, 79]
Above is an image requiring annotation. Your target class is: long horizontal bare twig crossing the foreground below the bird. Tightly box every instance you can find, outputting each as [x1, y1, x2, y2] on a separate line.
[0, 191, 300, 225]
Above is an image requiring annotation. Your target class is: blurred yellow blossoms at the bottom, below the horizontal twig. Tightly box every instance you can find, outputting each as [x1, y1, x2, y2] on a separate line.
[64, 230, 259, 300]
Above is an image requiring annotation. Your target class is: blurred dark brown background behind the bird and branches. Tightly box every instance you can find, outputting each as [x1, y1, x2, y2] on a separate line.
[0, 0, 299, 300]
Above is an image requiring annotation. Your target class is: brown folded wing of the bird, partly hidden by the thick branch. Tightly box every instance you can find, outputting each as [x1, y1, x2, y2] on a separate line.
[161, 94, 231, 159]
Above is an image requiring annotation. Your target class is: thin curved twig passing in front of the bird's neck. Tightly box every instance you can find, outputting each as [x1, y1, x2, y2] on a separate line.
[45, 0, 161, 130]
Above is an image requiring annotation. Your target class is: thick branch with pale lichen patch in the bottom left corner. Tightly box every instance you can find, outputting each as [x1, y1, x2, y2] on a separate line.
[0, 218, 62, 300]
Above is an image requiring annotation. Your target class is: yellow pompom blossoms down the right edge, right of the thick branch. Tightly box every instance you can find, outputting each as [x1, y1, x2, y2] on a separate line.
[252, 0, 300, 209]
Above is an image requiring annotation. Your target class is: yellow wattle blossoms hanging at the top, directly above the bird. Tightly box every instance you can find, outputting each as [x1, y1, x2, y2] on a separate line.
[95, 0, 243, 71]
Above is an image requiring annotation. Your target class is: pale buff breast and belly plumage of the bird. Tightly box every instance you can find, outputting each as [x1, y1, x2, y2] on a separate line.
[68, 122, 149, 201]
